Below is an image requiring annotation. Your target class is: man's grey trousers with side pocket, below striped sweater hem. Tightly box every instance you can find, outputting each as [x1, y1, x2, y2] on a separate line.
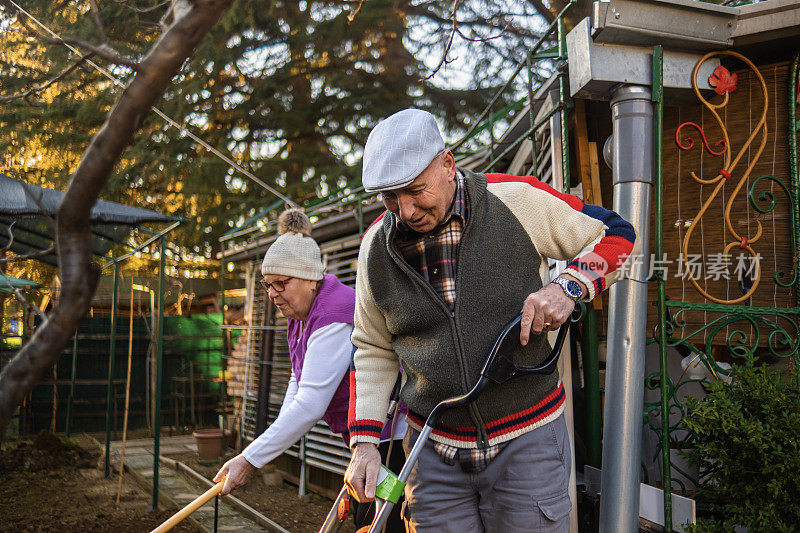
[403, 415, 572, 533]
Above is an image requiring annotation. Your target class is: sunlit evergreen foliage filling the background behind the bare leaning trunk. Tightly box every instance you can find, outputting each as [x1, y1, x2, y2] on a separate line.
[0, 0, 542, 275]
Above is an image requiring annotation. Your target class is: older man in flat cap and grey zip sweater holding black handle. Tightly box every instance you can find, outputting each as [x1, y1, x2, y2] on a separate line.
[345, 109, 635, 533]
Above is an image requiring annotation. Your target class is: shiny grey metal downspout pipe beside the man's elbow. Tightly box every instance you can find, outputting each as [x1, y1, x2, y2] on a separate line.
[600, 85, 653, 533]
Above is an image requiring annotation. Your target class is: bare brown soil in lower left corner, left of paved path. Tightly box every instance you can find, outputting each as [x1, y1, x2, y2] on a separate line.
[0, 433, 196, 533]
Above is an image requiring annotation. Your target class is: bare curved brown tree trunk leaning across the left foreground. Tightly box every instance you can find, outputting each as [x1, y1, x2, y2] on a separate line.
[0, 0, 232, 442]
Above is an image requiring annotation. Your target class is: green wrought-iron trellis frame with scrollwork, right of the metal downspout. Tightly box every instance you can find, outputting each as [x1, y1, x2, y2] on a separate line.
[644, 47, 800, 531]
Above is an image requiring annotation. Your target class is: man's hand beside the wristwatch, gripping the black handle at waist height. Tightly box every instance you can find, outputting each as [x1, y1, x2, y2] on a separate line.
[519, 274, 587, 346]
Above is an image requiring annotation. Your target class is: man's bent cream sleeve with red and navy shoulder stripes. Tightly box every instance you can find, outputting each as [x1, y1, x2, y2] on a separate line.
[486, 174, 636, 300]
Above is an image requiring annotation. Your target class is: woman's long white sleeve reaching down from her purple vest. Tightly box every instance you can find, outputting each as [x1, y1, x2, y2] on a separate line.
[242, 322, 353, 468]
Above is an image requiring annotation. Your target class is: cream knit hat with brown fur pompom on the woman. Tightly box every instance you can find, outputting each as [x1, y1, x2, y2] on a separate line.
[261, 209, 324, 281]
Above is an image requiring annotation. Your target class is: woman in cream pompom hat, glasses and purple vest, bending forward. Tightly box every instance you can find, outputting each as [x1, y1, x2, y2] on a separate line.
[214, 209, 406, 531]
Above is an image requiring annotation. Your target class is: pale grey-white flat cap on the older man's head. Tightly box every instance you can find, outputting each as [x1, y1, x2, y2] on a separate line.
[361, 109, 444, 192]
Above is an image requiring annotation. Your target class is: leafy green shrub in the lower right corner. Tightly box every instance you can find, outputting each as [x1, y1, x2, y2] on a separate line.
[686, 364, 800, 533]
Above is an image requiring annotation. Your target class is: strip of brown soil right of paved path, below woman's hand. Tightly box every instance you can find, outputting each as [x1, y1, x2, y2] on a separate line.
[166, 453, 356, 533]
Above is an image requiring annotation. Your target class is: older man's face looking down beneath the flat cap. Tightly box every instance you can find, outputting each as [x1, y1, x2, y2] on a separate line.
[381, 150, 456, 233]
